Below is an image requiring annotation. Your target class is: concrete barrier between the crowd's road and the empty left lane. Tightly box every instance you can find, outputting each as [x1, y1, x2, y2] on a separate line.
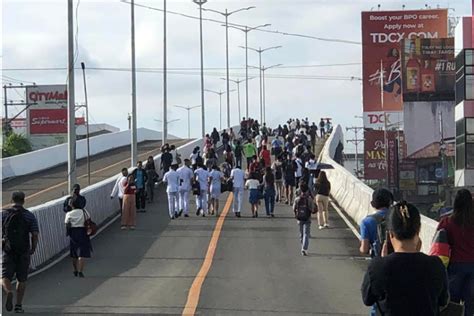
[25, 127, 238, 271]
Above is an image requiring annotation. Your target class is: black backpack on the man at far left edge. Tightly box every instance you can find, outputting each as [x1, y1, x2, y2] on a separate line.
[2, 208, 30, 254]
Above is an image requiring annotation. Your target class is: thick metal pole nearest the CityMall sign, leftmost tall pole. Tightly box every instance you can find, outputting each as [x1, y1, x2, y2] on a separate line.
[67, 0, 77, 192]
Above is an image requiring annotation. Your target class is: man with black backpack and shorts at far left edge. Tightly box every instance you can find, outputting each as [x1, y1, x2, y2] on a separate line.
[2, 192, 39, 313]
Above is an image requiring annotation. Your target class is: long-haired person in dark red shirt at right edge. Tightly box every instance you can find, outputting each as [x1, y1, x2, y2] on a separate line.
[438, 189, 474, 316]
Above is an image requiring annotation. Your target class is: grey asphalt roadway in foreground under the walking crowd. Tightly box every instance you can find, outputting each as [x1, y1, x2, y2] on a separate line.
[4, 187, 368, 315]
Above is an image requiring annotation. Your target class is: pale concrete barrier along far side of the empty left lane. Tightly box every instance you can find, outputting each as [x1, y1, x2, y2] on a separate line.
[2, 128, 176, 179]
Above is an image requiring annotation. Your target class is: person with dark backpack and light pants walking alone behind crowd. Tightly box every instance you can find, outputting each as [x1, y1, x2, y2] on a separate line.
[293, 183, 315, 256]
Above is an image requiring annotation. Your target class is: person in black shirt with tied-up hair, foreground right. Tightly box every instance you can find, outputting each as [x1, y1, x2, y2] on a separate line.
[362, 202, 449, 316]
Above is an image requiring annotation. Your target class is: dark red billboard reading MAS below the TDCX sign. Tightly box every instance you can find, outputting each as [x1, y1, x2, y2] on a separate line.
[364, 130, 398, 180]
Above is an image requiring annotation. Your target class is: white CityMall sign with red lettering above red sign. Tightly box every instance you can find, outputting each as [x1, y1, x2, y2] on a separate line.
[26, 84, 67, 109]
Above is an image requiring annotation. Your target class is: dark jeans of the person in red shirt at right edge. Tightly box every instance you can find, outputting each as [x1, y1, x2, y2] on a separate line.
[448, 262, 474, 316]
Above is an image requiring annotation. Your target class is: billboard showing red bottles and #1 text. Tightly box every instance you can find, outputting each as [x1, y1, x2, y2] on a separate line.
[402, 38, 456, 102]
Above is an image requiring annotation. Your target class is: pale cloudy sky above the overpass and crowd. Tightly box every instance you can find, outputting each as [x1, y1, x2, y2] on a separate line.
[1, 0, 471, 151]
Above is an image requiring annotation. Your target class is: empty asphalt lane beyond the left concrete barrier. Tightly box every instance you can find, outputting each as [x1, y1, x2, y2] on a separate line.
[2, 140, 188, 207]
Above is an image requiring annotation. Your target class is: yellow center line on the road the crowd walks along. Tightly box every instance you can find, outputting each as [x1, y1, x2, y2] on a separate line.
[183, 193, 233, 315]
